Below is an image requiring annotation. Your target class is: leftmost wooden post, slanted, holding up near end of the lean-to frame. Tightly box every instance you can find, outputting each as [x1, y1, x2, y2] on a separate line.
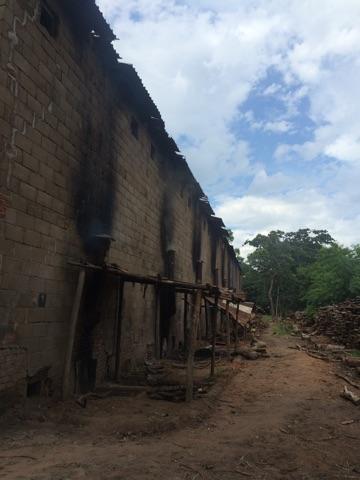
[62, 269, 86, 399]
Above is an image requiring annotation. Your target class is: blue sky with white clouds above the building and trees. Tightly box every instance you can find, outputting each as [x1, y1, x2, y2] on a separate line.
[97, 0, 360, 255]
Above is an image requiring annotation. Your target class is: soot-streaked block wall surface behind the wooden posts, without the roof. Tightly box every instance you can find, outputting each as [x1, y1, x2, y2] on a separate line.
[0, 0, 242, 396]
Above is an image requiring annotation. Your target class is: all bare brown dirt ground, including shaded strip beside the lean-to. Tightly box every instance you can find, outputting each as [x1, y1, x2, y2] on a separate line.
[0, 333, 360, 480]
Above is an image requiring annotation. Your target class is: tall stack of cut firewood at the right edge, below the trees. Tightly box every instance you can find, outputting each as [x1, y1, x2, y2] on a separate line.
[315, 297, 360, 348]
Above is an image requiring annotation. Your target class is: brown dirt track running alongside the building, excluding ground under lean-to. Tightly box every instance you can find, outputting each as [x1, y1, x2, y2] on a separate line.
[0, 333, 360, 480]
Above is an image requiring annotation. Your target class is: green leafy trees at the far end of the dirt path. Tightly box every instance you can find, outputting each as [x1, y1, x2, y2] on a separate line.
[242, 228, 360, 316]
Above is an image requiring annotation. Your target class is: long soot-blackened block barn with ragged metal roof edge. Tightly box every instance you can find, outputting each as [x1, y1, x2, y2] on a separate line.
[0, 0, 242, 404]
